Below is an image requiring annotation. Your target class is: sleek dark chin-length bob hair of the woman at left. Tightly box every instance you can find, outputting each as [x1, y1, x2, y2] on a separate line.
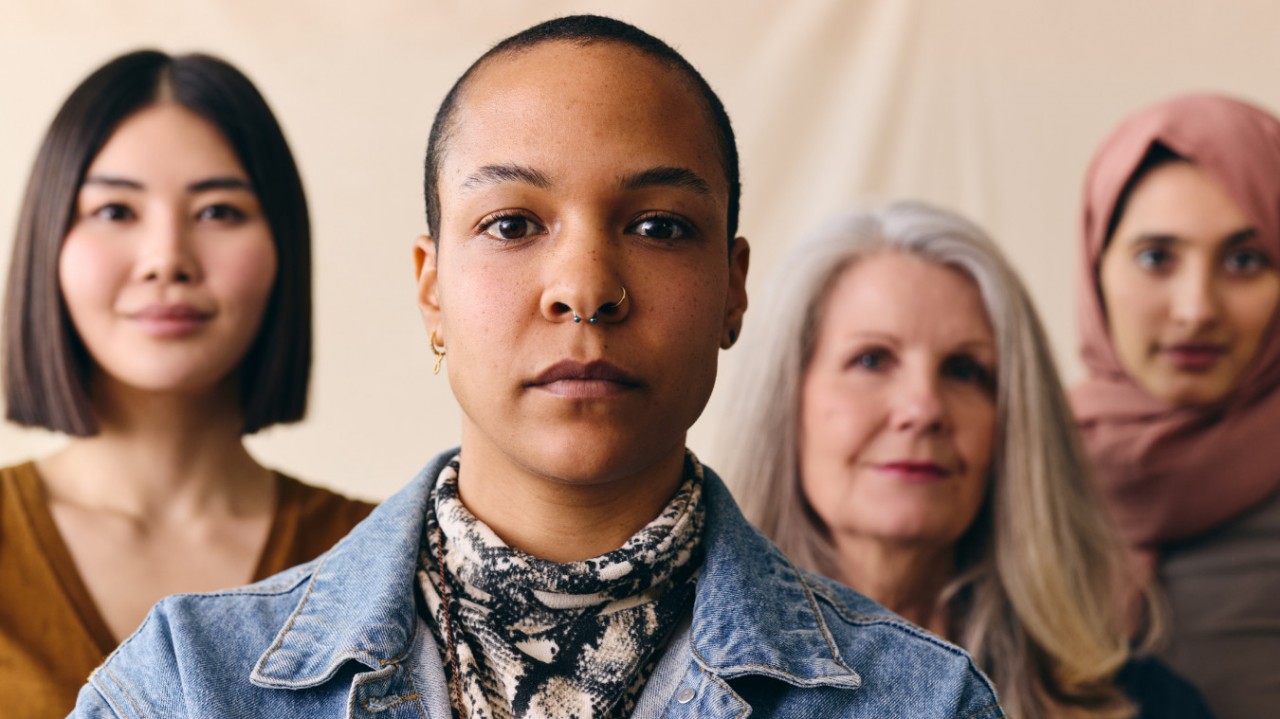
[3, 50, 311, 436]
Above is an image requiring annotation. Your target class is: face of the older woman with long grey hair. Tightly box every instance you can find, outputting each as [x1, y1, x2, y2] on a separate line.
[800, 252, 996, 548]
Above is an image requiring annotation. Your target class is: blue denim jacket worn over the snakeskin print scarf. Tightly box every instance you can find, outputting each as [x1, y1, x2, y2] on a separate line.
[72, 452, 1005, 719]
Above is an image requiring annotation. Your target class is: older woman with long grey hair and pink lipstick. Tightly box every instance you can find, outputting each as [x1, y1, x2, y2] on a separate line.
[722, 203, 1207, 719]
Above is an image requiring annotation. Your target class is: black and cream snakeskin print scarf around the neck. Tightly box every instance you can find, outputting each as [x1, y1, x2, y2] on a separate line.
[419, 453, 704, 719]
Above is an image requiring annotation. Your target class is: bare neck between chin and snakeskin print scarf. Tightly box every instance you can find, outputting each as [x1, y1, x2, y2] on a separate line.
[458, 431, 685, 563]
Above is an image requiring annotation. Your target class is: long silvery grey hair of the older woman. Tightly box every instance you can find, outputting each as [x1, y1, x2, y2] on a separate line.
[717, 202, 1133, 719]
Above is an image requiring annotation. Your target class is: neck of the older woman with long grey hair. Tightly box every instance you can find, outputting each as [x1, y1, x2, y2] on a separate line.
[836, 537, 955, 637]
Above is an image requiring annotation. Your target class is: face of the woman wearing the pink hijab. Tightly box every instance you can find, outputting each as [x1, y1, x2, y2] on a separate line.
[1098, 162, 1280, 406]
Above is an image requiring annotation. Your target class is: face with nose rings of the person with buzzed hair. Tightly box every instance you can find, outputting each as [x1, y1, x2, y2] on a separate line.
[419, 42, 746, 484]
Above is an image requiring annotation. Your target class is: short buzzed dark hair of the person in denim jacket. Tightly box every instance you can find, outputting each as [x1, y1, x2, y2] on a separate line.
[422, 15, 742, 244]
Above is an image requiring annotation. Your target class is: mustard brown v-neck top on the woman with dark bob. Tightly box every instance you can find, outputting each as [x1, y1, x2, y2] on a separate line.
[0, 462, 372, 719]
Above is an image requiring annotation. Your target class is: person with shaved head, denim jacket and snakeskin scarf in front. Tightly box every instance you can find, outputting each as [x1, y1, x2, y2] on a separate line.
[78, 17, 1004, 719]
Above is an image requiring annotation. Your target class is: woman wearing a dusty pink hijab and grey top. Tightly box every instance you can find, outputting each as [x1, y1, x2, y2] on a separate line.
[1071, 95, 1280, 719]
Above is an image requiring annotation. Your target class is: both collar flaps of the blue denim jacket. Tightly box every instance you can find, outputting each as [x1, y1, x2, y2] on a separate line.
[250, 450, 861, 690]
